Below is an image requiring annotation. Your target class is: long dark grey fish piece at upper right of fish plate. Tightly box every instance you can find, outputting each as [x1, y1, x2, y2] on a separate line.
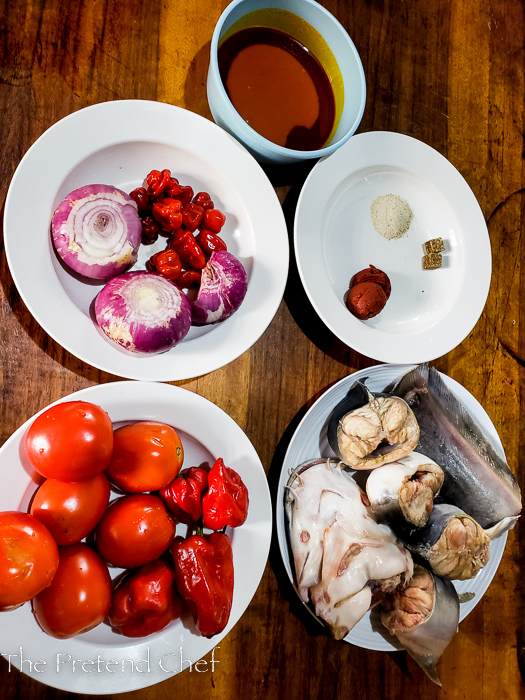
[390, 365, 522, 528]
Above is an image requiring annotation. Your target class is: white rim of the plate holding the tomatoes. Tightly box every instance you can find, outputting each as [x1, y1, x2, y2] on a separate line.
[0, 381, 273, 695]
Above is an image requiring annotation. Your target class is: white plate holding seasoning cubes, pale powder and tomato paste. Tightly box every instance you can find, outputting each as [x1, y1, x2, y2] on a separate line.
[294, 132, 492, 363]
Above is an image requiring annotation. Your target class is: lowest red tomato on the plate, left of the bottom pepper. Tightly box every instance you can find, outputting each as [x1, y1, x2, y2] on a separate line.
[33, 543, 112, 639]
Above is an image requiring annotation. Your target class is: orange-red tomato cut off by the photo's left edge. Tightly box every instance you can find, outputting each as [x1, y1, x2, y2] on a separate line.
[0, 511, 58, 611]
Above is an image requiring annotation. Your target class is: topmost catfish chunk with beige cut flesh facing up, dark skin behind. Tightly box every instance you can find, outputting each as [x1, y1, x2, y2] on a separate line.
[327, 381, 419, 469]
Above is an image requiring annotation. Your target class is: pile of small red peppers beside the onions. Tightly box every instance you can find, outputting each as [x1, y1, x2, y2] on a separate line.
[130, 169, 226, 289]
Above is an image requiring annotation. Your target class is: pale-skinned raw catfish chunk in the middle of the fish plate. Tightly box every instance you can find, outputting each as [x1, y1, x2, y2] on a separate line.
[366, 452, 443, 527]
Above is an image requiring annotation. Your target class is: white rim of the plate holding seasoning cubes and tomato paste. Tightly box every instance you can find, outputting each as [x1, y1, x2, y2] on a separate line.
[293, 131, 492, 364]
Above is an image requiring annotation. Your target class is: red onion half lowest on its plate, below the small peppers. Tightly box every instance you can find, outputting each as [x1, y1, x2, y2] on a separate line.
[95, 271, 191, 353]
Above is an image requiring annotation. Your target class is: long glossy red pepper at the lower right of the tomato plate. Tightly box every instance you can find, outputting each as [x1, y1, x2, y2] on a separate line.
[170, 532, 233, 637]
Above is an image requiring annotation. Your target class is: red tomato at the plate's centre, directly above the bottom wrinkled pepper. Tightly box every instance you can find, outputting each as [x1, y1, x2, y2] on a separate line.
[95, 493, 175, 569]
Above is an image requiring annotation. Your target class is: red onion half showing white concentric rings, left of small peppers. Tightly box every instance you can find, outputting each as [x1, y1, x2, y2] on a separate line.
[51, 185, 142, 279]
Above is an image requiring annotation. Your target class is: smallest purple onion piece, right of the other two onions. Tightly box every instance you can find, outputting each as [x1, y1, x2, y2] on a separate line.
[192, 250, 248, 324]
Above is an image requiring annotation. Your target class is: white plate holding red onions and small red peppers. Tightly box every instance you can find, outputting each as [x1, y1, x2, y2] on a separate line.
[4, 100, 289, 381]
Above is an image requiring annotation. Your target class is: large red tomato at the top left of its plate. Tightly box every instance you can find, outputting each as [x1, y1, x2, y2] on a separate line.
[25, 401, 113, 481]
